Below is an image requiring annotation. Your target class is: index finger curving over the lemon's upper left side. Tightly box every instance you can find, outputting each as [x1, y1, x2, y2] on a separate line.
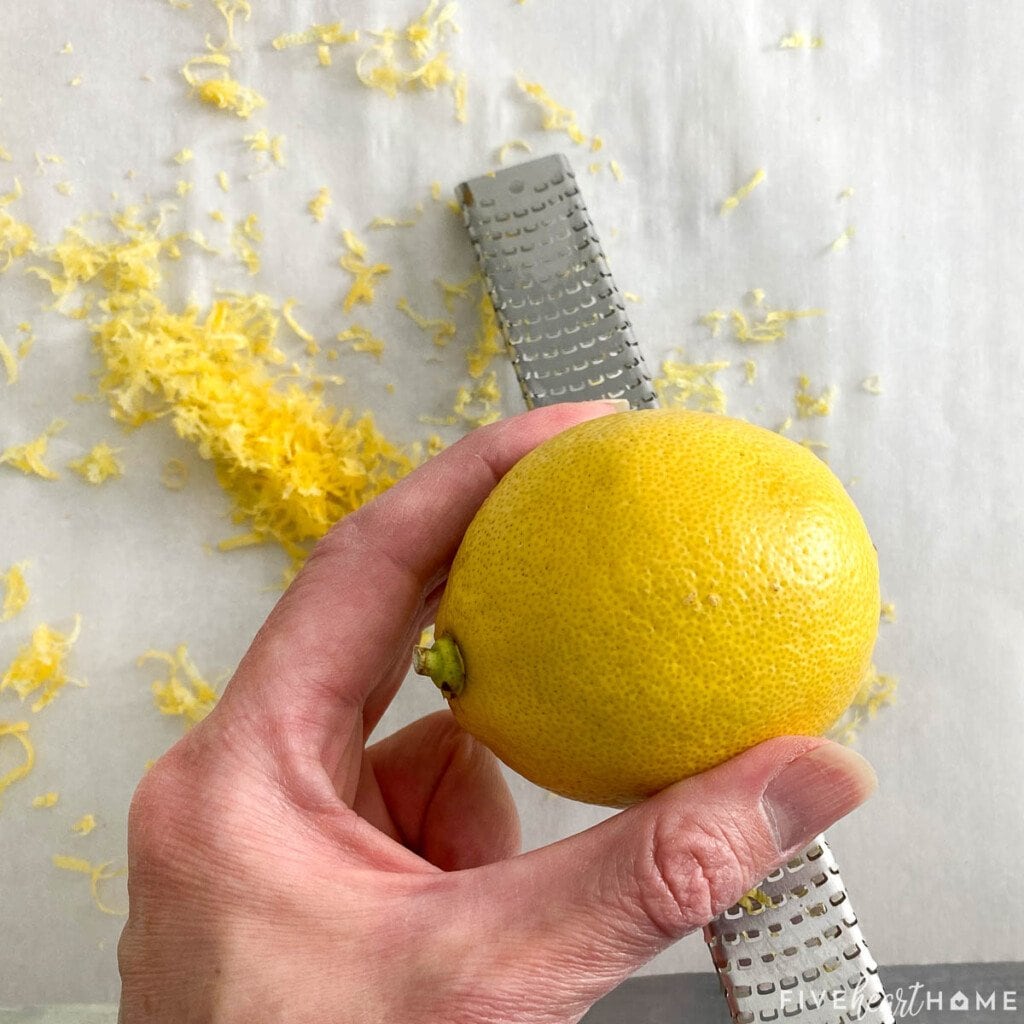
[223, 400, 622, 753]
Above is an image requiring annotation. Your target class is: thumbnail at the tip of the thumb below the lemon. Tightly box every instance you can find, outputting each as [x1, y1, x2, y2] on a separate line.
[761, 742, 879, 853]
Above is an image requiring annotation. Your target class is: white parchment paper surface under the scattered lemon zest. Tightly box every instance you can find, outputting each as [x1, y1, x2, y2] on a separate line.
[0, 0, 1024, 1004]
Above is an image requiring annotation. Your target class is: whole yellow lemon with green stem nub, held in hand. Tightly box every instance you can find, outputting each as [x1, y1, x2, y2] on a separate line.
[416, 410, 880, 806]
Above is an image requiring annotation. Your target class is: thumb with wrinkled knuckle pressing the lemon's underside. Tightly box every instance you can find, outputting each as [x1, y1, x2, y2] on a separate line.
[464, 736, 877, 1014]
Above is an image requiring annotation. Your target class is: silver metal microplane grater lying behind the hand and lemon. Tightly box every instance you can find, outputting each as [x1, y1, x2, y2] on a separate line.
[457, 155, 894, 1024]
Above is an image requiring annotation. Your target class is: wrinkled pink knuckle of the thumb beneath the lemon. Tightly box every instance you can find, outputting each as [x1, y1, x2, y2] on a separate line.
[643, 818, 755, 939]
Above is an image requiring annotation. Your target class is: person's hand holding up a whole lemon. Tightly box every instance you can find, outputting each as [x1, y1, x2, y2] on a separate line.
[118, 402, 873, 1024]
